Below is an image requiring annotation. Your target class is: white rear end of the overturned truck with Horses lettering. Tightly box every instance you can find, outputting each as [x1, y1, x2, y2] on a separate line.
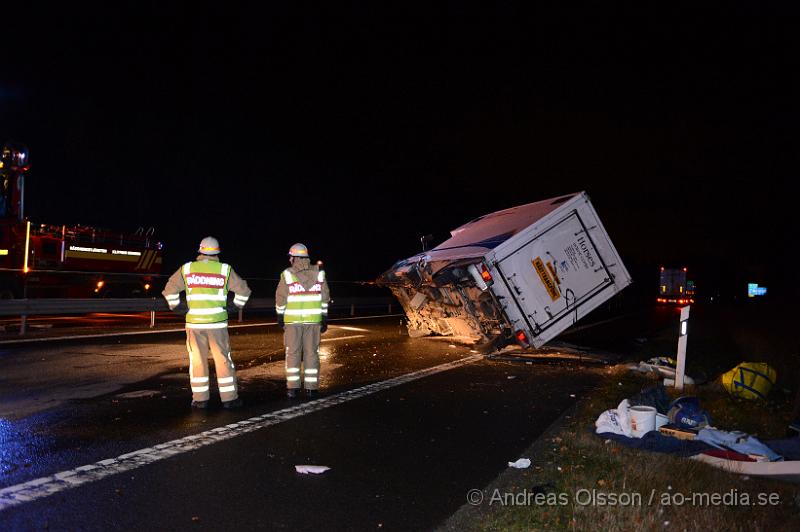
[484, 193, 631, 347]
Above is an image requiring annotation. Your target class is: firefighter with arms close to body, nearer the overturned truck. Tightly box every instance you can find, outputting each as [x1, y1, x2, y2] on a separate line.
[275, 244, 330, 398]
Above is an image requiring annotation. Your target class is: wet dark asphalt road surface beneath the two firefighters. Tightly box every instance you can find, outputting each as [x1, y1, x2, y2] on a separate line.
[0, 318, 656, 530]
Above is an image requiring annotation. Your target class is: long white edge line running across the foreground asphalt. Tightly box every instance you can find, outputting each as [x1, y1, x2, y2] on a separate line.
[0, 355, 483, 512]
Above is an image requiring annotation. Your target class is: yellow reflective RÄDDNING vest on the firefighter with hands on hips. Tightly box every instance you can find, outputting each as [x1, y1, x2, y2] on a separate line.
[181, 261, 231, 328]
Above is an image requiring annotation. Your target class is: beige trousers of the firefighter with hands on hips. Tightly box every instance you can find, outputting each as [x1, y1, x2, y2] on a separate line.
[186, 328, 239, 402]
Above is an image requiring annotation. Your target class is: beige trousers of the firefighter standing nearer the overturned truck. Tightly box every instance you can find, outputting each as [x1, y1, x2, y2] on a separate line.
[283, 323, 320, 390]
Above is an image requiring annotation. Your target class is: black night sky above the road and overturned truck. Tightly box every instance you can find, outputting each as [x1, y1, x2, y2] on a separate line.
[0, 6, 800, 295]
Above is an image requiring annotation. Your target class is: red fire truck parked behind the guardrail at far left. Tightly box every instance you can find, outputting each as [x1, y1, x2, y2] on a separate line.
[0, 143, 162, 298]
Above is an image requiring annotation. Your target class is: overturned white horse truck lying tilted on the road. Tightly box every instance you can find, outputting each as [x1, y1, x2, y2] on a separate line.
[377, 192, 631, 350]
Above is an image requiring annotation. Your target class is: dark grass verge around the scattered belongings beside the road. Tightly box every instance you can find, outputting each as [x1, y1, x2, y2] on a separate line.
[442, 360, 800, 530]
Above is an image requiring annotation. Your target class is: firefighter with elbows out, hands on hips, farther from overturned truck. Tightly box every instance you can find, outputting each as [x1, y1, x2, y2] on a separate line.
[162, 236, 250, 409]
